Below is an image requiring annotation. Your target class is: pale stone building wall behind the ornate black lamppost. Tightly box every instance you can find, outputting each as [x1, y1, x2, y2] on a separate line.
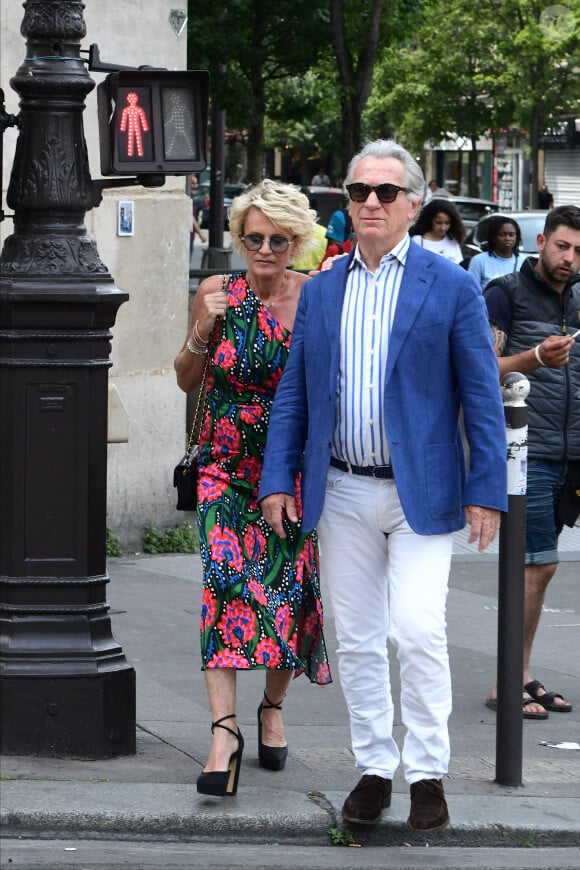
[0, 0, 191, 550]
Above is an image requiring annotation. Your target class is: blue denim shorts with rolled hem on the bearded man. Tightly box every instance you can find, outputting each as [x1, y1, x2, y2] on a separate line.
[526, 459, 566, 565]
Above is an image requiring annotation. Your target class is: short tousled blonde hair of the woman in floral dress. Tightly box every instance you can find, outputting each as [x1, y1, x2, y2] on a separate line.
[229, 178, 316, 260]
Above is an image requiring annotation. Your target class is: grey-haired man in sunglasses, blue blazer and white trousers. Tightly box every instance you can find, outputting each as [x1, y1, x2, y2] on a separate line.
[260, 140, 507, 830]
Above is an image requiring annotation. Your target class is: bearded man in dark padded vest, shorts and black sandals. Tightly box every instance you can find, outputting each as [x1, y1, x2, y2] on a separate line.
[484, 205, 580, 719]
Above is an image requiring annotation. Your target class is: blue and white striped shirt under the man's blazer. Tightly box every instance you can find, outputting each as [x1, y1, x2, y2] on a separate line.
[332, 234, 410, 465]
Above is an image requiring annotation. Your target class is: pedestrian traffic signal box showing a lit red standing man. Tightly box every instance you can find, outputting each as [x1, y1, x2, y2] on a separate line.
[97, 69, 209, 175]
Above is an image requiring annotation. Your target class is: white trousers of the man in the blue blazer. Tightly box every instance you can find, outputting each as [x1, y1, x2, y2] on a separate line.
[318, 467, 453, 784]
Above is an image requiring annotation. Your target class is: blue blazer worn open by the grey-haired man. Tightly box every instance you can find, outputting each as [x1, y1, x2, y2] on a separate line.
[259, 245, 507, 535]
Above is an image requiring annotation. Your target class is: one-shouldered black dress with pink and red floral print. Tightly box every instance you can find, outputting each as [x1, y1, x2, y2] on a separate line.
[197, 275, 331, 684]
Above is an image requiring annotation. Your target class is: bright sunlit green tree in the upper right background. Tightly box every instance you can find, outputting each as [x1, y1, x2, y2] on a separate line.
[365, 0, 580, 196]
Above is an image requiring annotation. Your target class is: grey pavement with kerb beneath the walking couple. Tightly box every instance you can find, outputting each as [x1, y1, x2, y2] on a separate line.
[0, 528, 580, 847]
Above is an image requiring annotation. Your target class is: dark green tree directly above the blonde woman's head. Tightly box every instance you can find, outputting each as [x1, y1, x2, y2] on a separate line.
[188, 0, 329, 182]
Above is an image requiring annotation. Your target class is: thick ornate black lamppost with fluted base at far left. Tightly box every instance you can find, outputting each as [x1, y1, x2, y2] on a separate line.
[0, 0, 136, 758]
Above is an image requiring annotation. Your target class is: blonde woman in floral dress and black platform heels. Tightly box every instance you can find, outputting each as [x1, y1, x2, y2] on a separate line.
[175, 179, 331, 795]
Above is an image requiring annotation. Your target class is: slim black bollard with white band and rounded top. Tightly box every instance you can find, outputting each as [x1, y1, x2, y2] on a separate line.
[496, 372, 530, 786]
